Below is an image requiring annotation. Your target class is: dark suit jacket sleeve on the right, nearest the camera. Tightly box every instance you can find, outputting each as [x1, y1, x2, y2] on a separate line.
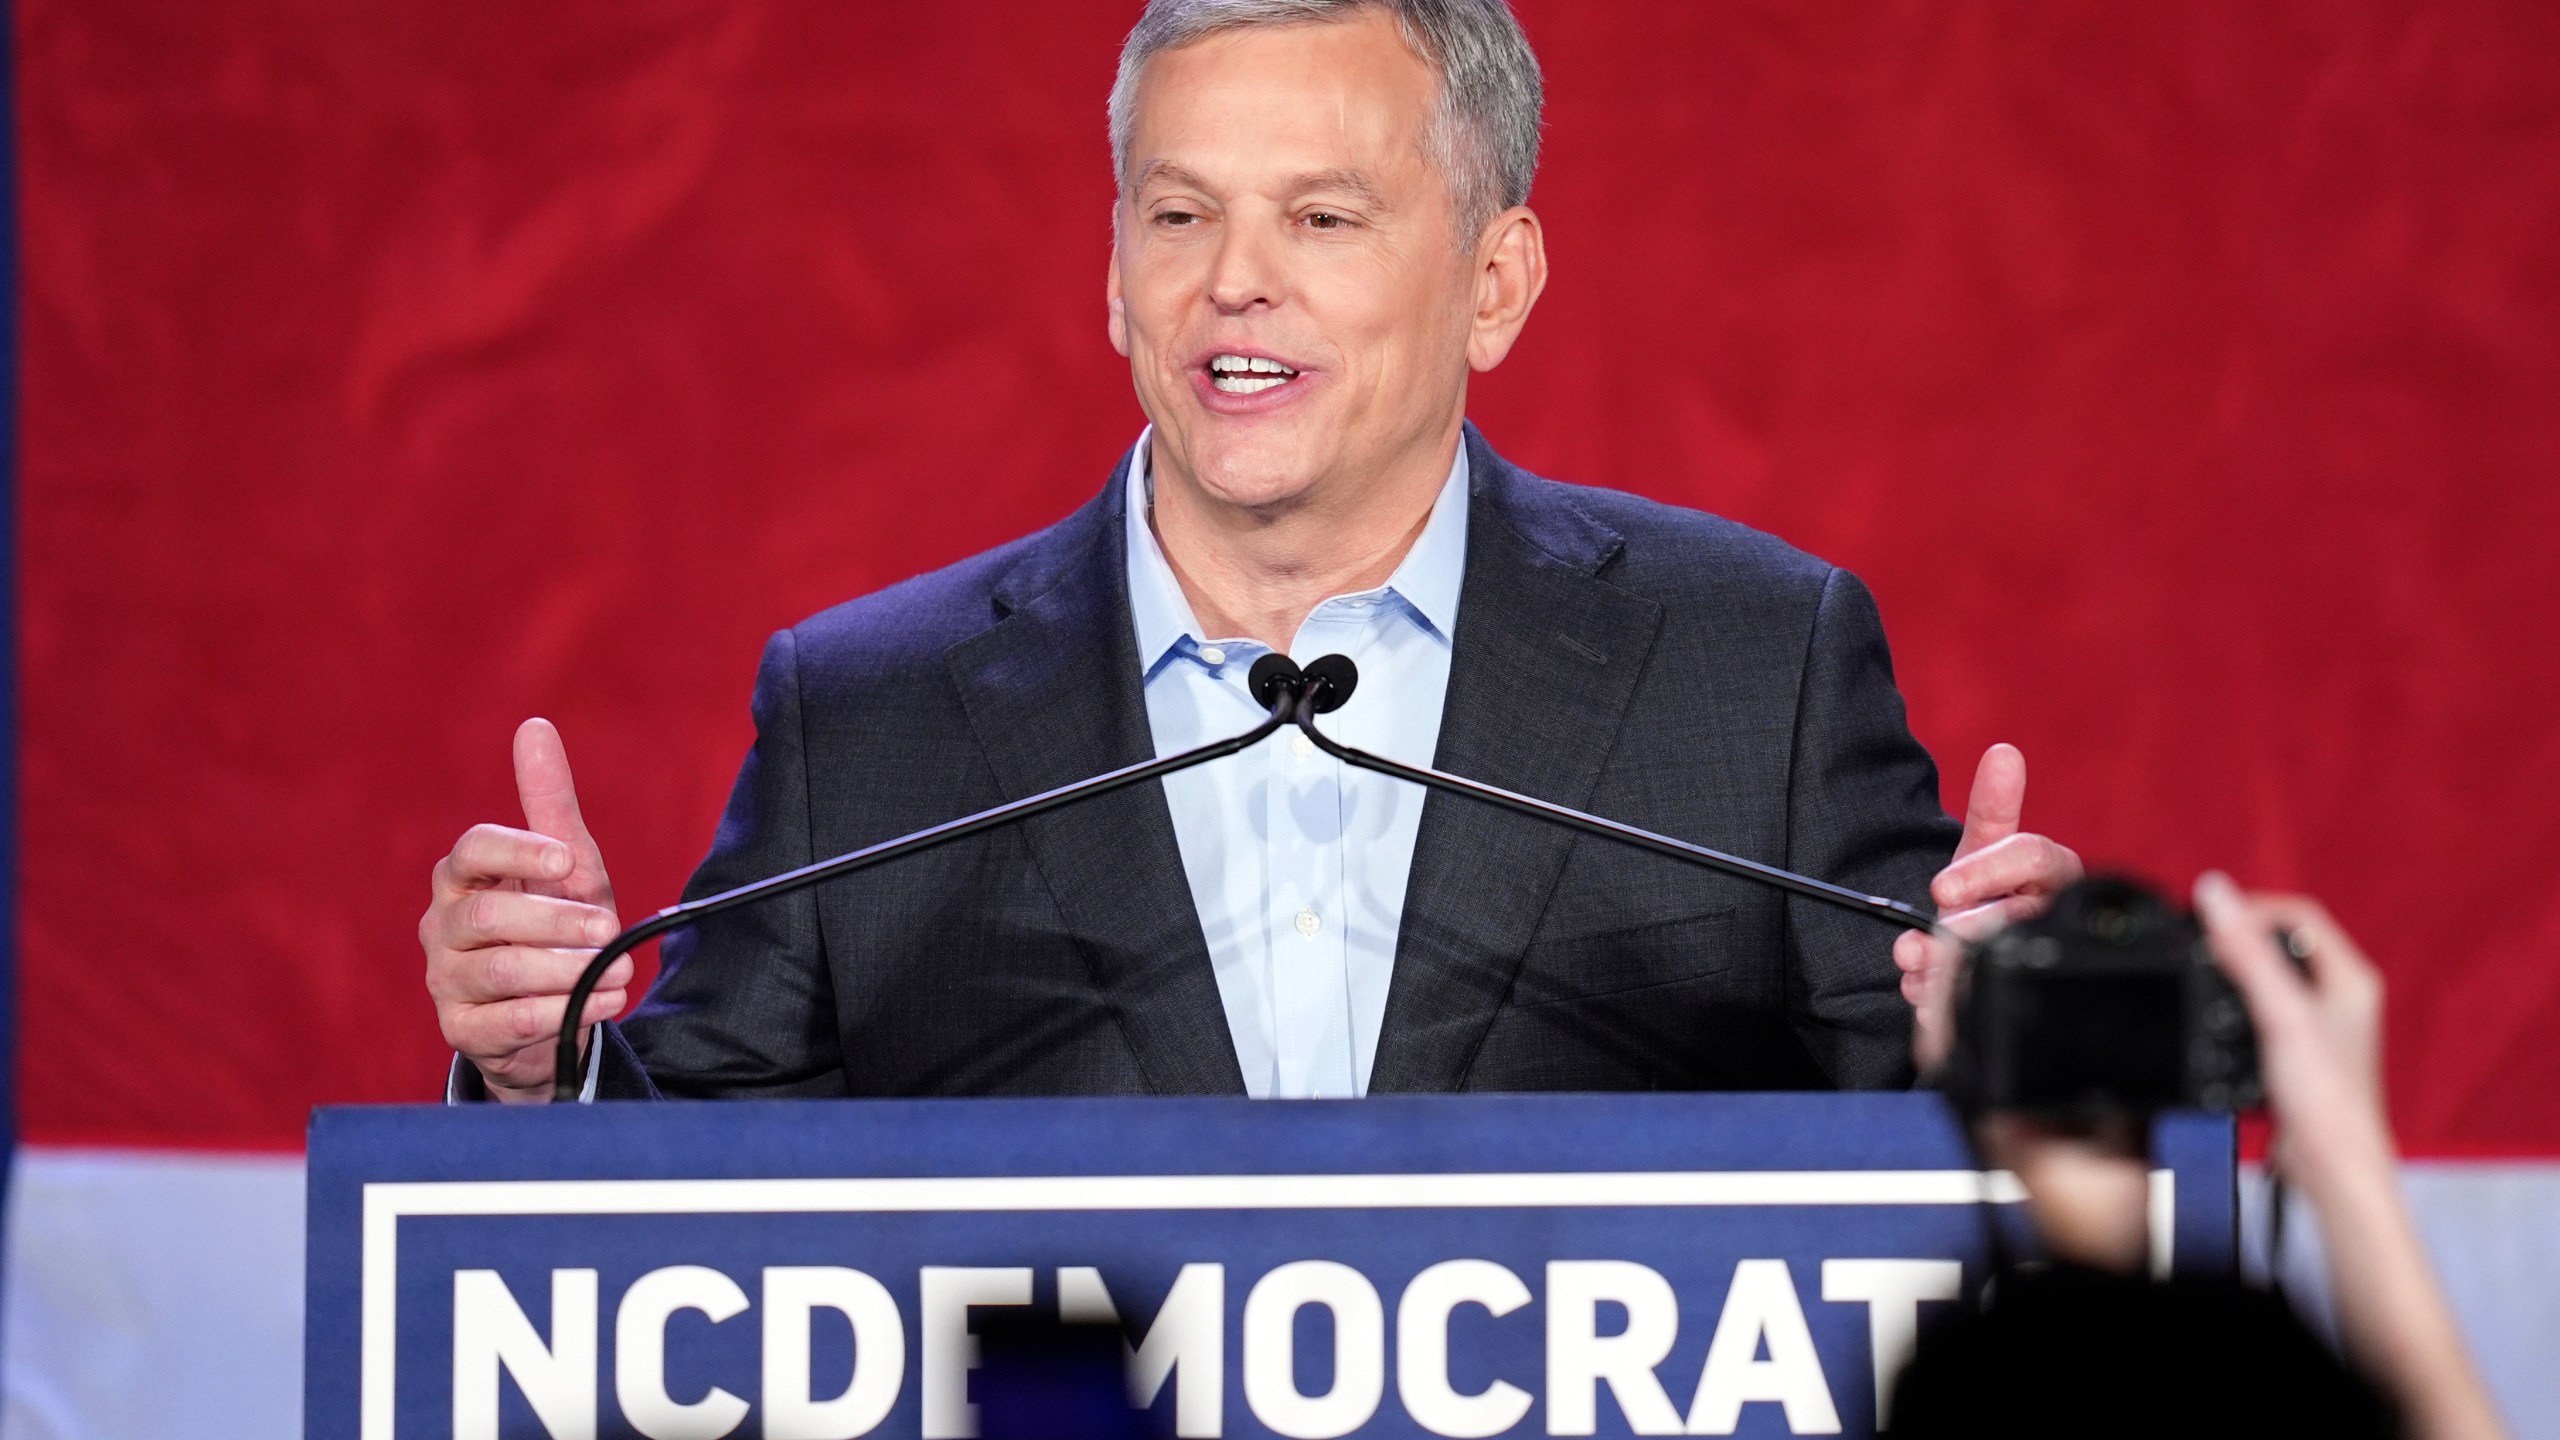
[1787, 569, 1961, 1089]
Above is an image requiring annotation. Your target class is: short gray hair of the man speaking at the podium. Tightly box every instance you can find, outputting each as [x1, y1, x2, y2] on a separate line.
[1111, 0, 1546, 243]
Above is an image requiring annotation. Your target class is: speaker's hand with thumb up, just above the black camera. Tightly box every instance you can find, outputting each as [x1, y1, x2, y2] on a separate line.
[1894, 746, 2081, 1071]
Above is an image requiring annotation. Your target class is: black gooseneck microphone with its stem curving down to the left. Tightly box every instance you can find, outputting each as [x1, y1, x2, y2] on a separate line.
[550, 653, 1310, 1102]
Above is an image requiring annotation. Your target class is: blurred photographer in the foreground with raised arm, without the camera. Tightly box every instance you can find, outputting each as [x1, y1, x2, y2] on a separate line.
[1892, 874, 2504, 1440]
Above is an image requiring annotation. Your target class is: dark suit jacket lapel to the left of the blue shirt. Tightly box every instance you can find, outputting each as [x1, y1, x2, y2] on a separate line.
[947, 456, 1244, 1094]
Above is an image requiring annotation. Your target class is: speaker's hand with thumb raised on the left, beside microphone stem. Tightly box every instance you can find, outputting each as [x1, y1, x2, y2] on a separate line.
[417, 720, 632, 1104]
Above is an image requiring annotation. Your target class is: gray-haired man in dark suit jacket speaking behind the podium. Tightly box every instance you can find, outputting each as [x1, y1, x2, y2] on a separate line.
[420, 0, 2079, 1099]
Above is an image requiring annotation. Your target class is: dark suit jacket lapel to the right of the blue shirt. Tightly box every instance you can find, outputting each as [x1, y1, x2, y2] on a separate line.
[1370, 425, 1661, 1094]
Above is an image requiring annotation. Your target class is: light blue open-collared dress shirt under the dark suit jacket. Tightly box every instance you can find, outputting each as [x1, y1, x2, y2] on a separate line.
[1126, 430, 1467, 1097]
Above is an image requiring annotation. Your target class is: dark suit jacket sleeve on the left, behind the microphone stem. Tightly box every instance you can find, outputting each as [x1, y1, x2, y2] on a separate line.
[596, 630, 845, 1099]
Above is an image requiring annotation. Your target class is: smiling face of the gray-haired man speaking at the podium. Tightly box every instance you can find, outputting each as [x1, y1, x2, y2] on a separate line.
[1111, 13, 1475, 512]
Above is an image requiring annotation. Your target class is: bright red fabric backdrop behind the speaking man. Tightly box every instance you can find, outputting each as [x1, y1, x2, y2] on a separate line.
[15, 0, 2560, 1153]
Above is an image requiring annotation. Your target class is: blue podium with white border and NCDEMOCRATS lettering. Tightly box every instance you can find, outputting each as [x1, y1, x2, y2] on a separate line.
[305, 1094, 2237, 1440]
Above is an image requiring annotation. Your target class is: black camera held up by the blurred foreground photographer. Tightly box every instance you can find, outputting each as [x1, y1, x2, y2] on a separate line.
[1940, 876, 2291, 1117]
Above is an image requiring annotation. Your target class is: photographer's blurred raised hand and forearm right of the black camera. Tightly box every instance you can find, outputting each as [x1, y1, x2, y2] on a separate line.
[2196, 871, 2504, 1440]
